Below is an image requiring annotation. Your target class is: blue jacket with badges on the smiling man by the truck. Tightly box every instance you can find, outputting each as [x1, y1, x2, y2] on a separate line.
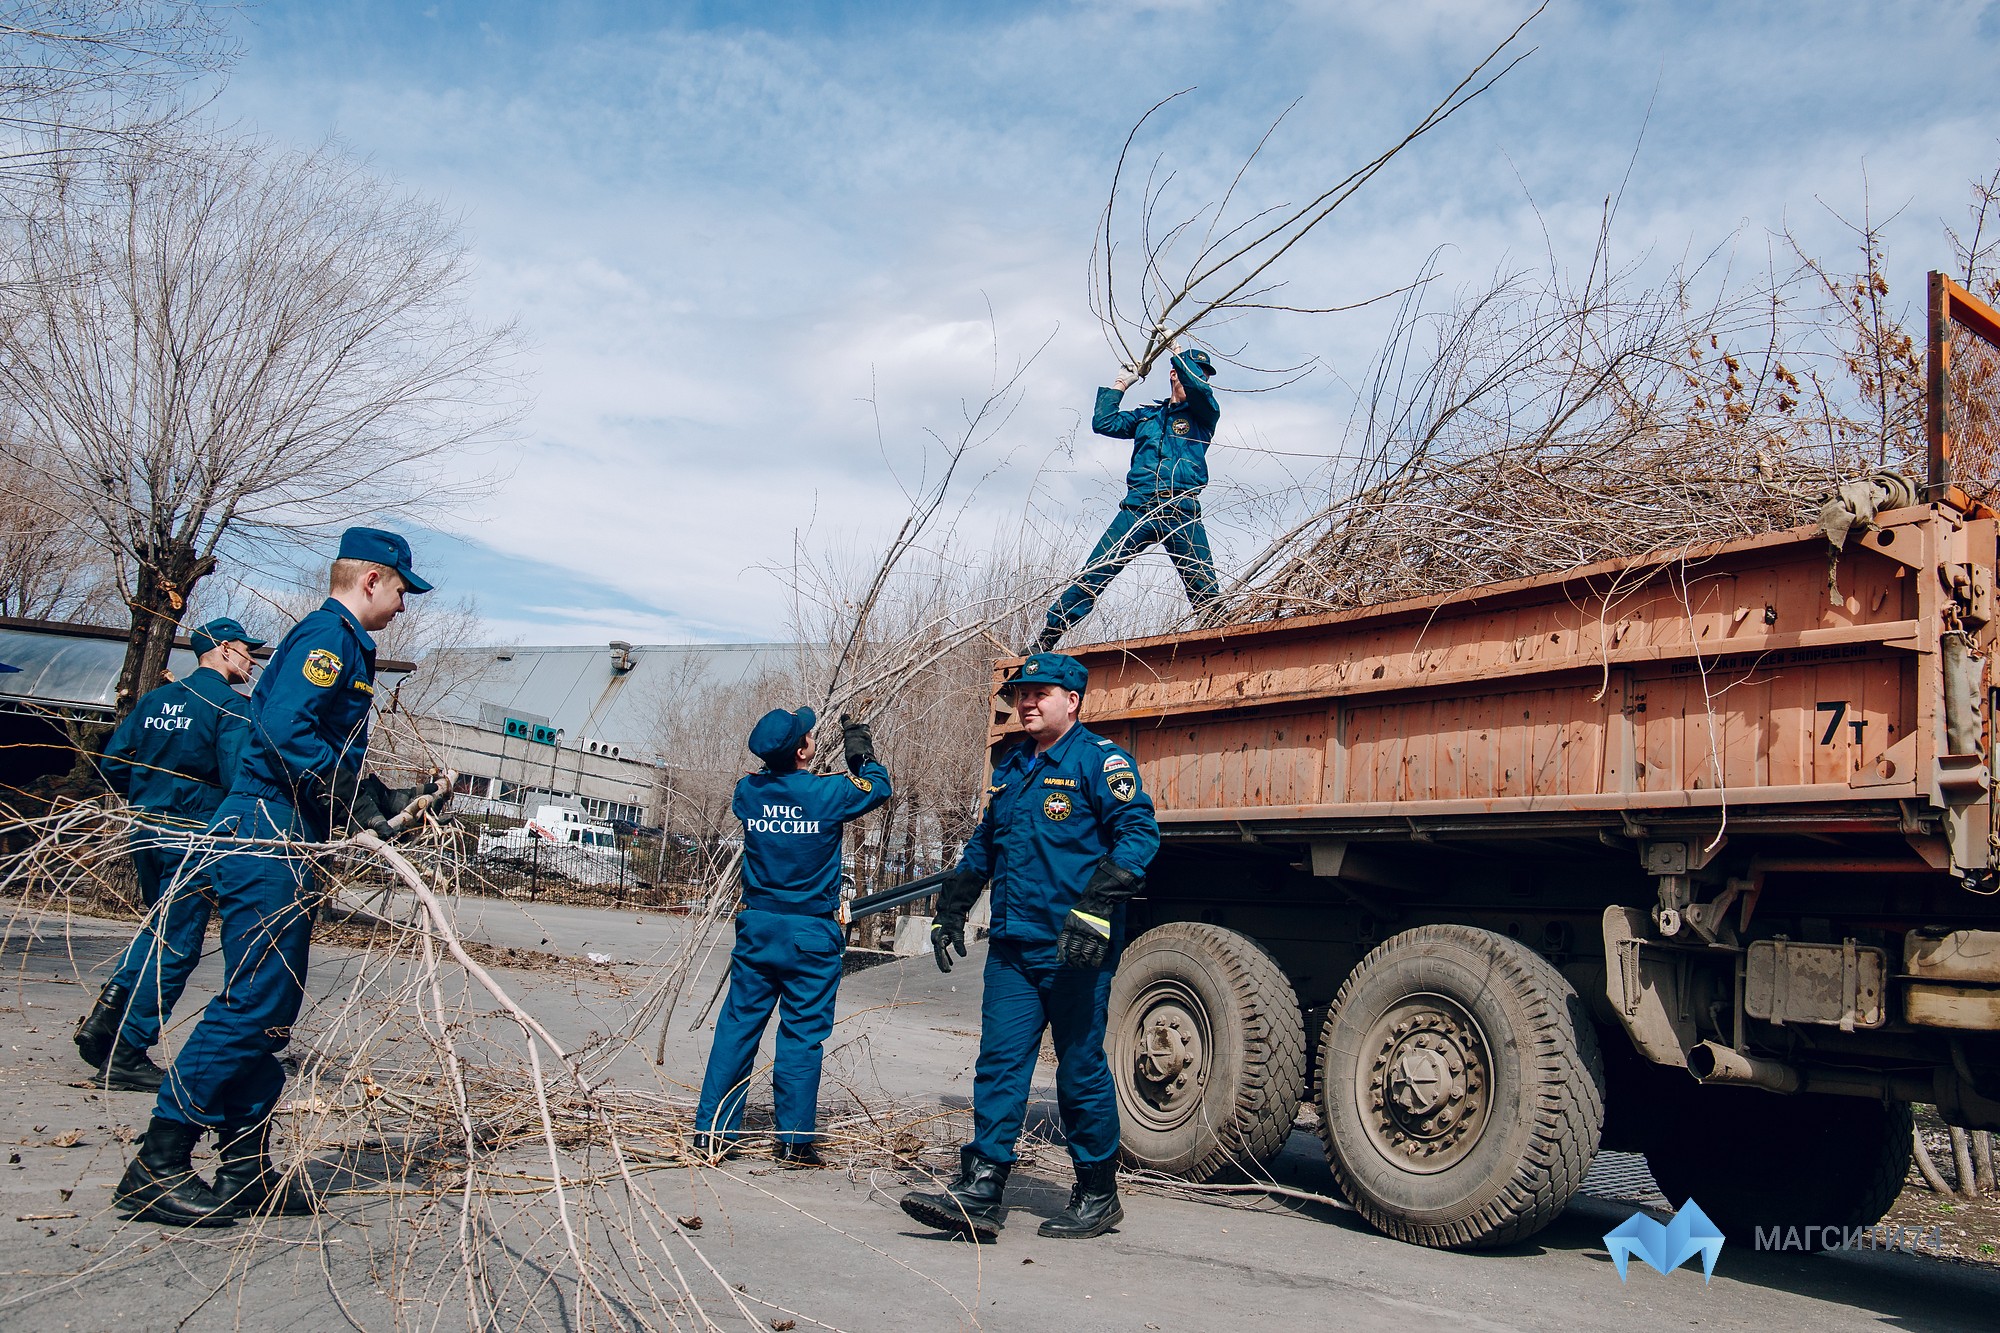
[958, 725, 1160, 945]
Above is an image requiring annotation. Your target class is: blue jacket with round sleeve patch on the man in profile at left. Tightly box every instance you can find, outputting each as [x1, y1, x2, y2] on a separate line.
[232, 598, 374, 837]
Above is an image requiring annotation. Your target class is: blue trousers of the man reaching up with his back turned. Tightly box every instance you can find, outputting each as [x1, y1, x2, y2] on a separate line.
[694, 909, 844, 1143]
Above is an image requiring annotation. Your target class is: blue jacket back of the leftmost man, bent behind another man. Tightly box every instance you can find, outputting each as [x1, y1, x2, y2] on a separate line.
[104, 667, 250, 827]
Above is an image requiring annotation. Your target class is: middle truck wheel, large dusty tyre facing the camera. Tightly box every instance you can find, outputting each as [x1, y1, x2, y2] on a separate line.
[1318, 925, 1604, 1249]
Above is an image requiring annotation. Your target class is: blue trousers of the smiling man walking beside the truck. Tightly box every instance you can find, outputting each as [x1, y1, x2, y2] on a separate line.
[972, 939, 1118, 1165]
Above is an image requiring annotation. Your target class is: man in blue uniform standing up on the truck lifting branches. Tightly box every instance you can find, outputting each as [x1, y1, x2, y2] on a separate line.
[1034, 344, 1222, 652]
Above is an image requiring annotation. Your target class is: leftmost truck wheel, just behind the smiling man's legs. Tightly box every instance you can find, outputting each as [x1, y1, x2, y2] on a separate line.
[1104, 921, 1306, 1181]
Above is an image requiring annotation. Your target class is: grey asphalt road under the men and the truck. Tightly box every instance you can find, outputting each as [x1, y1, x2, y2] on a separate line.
[0, 903, 2000, 1333]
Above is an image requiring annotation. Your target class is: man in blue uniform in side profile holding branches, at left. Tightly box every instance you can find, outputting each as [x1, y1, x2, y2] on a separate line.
[112, 528, 430, 1227]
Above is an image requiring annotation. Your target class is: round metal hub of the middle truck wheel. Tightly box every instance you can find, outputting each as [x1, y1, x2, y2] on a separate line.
[1356, 995, 1492, 1175]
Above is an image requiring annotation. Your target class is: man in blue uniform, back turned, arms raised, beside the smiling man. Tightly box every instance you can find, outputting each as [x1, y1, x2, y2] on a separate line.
[694, 709, 890, 1167]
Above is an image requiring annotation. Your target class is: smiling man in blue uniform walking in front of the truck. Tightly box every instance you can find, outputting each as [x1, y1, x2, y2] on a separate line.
[902, 652, 1160, 1241]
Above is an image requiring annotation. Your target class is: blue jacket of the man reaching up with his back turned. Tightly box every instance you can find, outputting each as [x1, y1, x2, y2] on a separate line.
[730, 763, 888, 917]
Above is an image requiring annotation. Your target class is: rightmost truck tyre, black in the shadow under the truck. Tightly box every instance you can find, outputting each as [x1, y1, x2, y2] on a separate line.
[1646, 1079, 1912, 1249]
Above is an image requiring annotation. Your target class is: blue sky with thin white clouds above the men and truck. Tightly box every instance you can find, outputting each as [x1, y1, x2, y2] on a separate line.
[216, 0, 2000, 642]
